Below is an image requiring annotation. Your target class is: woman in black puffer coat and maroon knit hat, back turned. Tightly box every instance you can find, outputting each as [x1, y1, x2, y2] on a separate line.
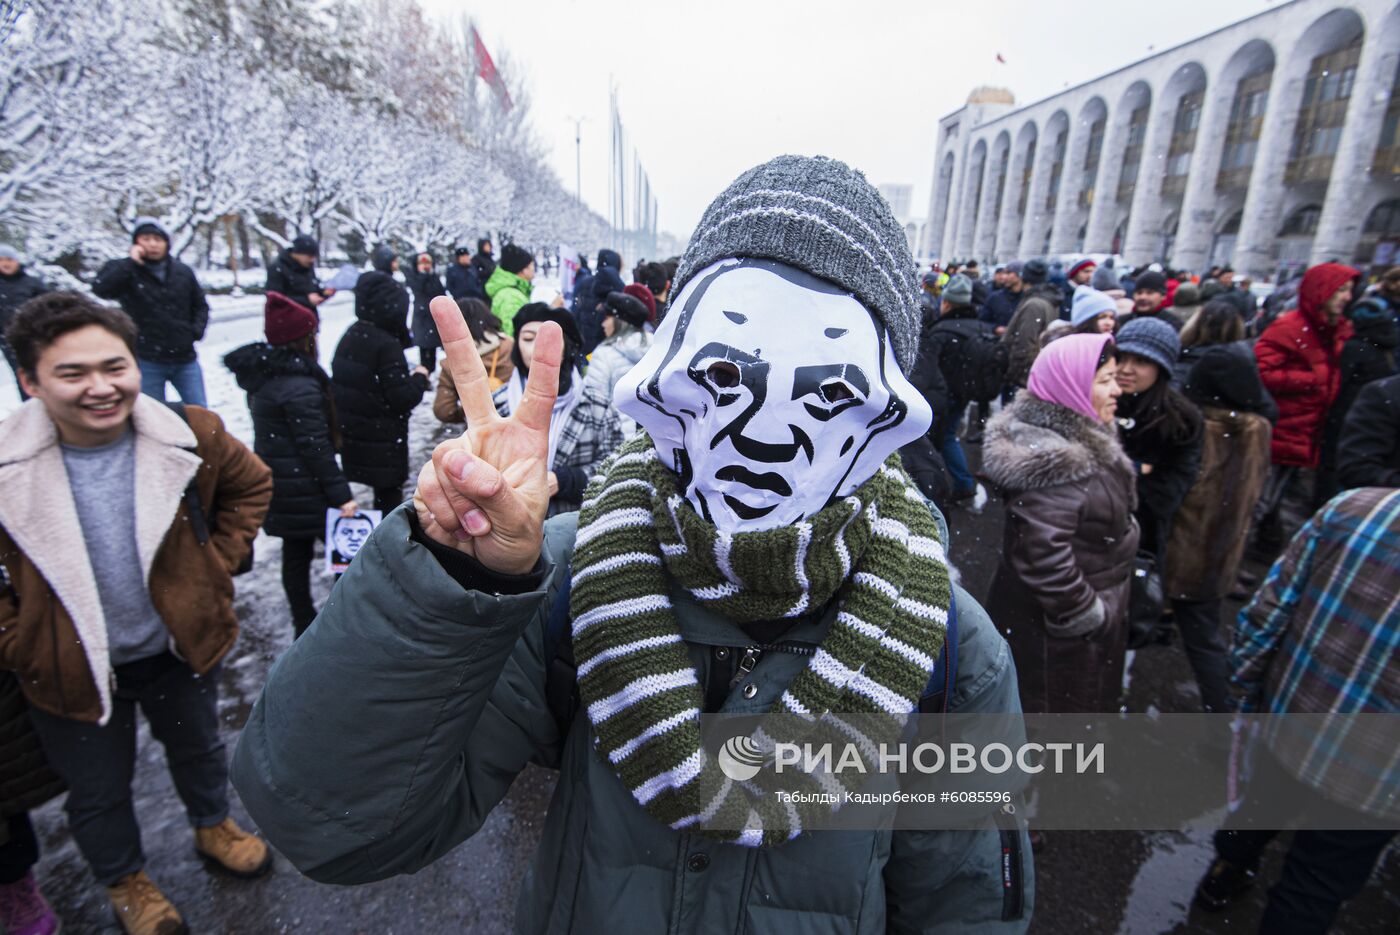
[224, 293, 358, 637]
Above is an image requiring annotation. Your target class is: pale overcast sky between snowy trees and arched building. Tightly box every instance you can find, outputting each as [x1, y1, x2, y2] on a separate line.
[424, 0, 1274, 239]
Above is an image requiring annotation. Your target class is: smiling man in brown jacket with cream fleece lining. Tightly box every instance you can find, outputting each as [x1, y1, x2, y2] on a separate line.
[0, 293, 272, 935]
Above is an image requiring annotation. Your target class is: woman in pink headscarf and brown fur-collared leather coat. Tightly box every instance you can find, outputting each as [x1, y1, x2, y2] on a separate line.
[983, 335, 1138, 712]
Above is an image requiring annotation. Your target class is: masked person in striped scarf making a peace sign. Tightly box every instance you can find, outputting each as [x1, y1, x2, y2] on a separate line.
[234, 155, 1033, 935]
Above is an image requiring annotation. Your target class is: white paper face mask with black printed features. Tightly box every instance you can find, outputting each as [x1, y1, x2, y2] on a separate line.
[613, 259, 932, 532]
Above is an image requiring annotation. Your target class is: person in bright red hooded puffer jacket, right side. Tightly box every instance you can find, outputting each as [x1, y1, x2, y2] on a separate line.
[1254, 263, 1361, 554]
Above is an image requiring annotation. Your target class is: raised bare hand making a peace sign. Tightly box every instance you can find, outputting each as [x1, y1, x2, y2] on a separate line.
[413, 295, 564, 574]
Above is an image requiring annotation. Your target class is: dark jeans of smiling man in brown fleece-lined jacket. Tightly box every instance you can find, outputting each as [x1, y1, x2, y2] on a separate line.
[29, 652, 228, 886]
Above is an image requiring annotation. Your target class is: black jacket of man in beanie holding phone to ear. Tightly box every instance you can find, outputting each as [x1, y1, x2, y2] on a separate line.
[92, 231, 209, 364]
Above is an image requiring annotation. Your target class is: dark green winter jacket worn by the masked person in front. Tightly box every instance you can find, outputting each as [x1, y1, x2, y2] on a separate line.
[232, 507, 1033, 935]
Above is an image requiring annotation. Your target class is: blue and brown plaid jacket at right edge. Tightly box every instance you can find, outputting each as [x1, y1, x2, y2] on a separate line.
[1231, 487, 1400, 817]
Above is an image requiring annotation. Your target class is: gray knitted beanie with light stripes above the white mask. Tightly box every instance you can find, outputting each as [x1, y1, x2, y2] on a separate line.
[672, 155, 921, 374]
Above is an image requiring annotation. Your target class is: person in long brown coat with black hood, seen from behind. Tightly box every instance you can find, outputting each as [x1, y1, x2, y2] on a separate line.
[1165, 298, 1278, 711]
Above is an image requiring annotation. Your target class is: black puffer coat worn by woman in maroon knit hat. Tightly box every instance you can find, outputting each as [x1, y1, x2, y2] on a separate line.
[224, 343, 353, 539]
